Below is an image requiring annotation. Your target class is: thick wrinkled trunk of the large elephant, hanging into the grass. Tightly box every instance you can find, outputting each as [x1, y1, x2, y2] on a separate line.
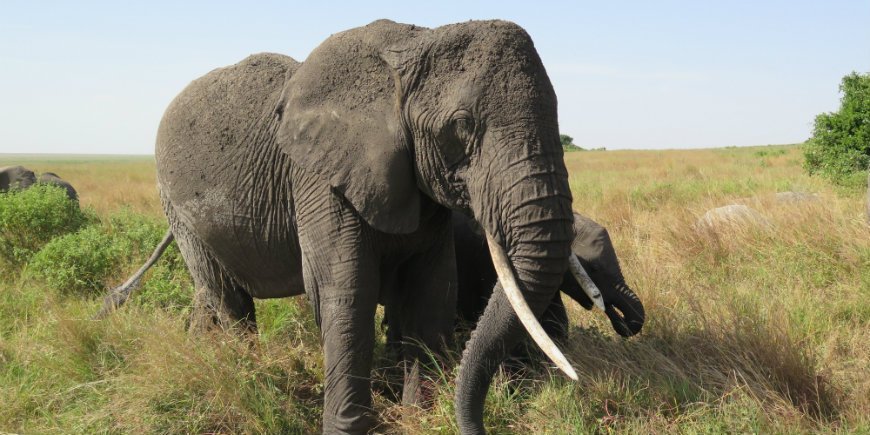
[455, 166, 573, 433]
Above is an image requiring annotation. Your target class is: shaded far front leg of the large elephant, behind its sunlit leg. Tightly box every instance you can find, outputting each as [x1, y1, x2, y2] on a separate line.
[394, 233, 457, 406]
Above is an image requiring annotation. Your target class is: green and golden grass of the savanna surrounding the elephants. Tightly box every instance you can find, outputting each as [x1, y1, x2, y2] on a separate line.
[0, 146, 870, 433]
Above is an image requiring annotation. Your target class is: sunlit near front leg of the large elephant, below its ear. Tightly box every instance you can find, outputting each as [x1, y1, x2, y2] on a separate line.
[296, 178, 380, 434]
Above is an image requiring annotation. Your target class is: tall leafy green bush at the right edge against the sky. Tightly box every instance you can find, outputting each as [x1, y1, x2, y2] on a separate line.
[804, 72, 870, 185]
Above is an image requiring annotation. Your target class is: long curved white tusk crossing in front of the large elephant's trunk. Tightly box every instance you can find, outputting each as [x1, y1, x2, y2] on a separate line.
[486, 233, 578, 381]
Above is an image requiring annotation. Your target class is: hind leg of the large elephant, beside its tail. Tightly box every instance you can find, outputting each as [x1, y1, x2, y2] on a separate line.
[172, 223, 257, 333]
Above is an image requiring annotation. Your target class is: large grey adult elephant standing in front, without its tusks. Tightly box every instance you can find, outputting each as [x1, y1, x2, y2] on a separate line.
[156, 21, 572, 433]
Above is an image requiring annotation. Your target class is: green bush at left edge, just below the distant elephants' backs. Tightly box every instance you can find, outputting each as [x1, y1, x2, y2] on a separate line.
[0, 184, 95, 266]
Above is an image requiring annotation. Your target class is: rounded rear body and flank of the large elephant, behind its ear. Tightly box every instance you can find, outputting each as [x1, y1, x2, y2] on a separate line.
[155, 53, 299, 297]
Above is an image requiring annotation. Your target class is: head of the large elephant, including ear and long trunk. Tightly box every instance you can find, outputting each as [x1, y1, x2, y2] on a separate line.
[276, 21, 573, 433]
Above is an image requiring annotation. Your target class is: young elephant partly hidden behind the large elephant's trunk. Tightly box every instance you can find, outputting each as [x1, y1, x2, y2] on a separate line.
[453, 213, 646, 338]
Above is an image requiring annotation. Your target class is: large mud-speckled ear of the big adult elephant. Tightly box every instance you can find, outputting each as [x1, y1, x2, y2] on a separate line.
[278, 26, 421, 234]
